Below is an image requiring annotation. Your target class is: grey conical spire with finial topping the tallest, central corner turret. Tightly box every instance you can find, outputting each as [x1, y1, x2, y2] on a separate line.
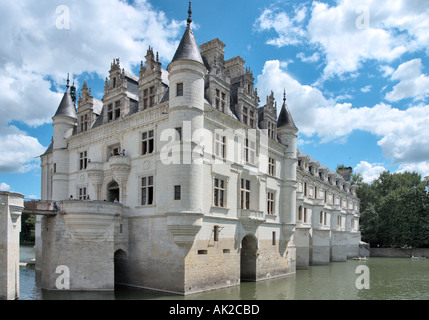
[171, 1, 204, 64]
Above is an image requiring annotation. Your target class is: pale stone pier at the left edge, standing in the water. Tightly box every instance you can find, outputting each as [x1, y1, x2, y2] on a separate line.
[0, 191, 24, 300]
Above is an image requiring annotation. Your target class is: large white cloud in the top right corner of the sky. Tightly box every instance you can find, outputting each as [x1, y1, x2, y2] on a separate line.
[257, 0, 429, 79]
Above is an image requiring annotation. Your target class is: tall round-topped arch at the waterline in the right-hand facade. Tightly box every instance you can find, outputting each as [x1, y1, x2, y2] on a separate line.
[240, 234, 258, 281]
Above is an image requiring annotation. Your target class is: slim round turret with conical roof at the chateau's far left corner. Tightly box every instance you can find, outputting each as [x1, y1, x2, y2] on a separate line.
[52, 78, 77, 201]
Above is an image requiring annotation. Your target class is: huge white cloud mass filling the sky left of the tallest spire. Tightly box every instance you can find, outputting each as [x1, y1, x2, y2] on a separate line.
[0, 0, 185, 173]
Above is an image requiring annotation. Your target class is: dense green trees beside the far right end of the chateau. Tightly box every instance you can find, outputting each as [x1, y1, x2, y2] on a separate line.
[356, 171, 429, 247]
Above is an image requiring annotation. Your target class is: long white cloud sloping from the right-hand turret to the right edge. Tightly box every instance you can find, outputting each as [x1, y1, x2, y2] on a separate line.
[257, 60, 429, 173]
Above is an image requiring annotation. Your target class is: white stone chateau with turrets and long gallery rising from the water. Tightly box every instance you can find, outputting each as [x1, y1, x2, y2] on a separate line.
[36, 3, 360, 295]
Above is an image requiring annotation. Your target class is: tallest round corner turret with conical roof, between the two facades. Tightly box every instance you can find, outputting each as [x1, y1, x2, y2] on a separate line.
[167, 2, 207, 212]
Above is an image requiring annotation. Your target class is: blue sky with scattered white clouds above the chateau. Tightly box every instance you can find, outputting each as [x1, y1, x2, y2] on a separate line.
[0, 0, 429, 199]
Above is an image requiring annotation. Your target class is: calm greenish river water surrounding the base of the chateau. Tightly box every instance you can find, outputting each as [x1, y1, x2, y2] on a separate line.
[20, 246, 429, 300]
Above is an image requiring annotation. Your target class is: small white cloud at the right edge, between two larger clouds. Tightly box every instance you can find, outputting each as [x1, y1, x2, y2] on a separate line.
[386, 59, 429, 102]
